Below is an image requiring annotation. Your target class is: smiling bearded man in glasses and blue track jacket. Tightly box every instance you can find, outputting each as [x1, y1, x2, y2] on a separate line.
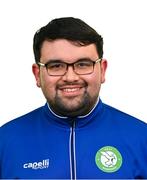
[0, 17, 147, 179]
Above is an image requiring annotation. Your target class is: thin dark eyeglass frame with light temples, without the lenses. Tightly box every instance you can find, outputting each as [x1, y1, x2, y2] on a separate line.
[37, 58, 102, 76]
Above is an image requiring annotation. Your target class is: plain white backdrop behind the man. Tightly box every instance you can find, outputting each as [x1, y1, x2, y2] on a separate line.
[0, 0, 147, 125]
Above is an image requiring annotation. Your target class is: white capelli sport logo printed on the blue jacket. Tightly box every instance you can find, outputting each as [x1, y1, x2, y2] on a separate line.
[23, 159, 49, 169]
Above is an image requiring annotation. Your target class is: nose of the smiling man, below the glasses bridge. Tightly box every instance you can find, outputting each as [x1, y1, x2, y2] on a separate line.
[63, 66, 79, 82]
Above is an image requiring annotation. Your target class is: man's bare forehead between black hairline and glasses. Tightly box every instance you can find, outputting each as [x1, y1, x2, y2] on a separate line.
[41, 39, 98, 60]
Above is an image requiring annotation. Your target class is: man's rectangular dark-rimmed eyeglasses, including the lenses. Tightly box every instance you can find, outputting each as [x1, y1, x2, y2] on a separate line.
[37, 59, 101, 76]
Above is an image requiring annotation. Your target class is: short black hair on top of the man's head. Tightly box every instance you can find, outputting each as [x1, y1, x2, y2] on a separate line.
[33, 17, 103, 63]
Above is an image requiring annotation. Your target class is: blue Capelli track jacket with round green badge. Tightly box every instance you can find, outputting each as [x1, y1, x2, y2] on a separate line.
[0, 100, 147, 179]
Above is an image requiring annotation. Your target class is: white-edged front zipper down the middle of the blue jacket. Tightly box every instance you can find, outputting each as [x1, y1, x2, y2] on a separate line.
[69, 121, 76, 180]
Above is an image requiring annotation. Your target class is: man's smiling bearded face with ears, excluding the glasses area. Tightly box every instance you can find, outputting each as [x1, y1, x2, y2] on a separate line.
[33, 39, 107, 117]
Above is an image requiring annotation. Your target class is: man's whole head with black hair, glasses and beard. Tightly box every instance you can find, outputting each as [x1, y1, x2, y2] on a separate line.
[33, 17, 107, 117]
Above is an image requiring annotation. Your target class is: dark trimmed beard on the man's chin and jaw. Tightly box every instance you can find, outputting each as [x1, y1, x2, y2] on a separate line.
[48, 90, 98, 117]
